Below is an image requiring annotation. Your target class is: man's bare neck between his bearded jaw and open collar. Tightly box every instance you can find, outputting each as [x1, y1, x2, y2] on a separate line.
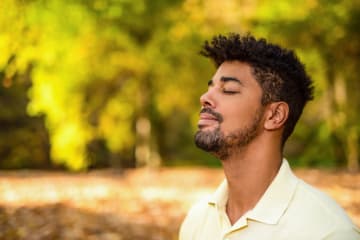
[222, 139, 282, 224]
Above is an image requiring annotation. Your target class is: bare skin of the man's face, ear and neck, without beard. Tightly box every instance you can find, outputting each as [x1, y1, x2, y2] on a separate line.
[198, 61, 289, 224]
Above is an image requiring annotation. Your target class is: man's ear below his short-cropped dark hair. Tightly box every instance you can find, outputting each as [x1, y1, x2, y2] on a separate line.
[264, 102, 289, 130]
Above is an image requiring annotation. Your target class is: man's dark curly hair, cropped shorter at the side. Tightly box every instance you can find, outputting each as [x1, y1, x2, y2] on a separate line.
[200, 33, 313, 145]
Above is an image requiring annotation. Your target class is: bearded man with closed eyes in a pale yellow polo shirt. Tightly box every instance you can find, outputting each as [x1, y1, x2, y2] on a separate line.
[180, 34, 360, 240]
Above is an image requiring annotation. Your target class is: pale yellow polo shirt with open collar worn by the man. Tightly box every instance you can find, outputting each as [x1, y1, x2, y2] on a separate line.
[179, 159, 360, 240]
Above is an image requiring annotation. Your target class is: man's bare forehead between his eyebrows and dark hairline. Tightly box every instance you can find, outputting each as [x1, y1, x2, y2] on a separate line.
[213, 61, 257, 85]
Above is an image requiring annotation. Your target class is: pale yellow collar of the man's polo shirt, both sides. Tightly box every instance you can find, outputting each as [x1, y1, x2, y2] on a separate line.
[208, 159, 299, 224]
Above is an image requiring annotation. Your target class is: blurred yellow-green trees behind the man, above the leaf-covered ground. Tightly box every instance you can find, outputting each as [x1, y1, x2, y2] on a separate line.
[0, 0, 360, 170]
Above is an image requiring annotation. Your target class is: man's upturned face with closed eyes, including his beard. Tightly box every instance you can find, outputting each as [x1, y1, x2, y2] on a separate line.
[195, 61, 264, 160]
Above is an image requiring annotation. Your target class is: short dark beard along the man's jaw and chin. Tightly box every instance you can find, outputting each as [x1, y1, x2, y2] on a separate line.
[195, 107, 263, 160]
